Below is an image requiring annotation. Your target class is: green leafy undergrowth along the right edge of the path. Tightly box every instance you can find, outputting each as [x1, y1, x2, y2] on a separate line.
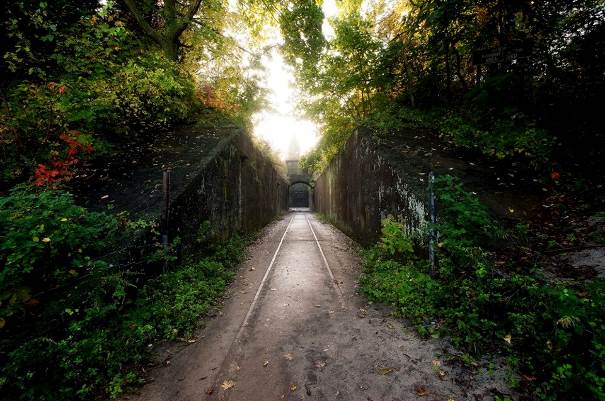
[362, 176, 605, 401]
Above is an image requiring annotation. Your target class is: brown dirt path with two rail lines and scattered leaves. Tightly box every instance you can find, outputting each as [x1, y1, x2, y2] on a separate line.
[129, 212, 506, 401]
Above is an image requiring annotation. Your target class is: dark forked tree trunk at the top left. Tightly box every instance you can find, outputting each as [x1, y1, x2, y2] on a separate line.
[124, 0, 202, 60]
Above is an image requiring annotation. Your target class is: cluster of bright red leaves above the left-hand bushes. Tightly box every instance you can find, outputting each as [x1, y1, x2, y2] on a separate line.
[34, 131, 93, 186]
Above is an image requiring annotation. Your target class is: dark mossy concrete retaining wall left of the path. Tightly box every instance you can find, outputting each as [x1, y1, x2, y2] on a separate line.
[168, 129, 288, 242]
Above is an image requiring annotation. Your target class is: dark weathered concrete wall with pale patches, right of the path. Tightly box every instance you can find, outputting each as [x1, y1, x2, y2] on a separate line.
[314, 128, 430, 244]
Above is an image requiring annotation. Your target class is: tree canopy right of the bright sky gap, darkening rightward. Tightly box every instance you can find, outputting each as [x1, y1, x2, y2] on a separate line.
[264, 0, 605, 173]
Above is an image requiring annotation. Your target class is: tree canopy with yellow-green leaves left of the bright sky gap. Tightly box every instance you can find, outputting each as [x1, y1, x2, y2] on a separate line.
[0, 0, 262, 188]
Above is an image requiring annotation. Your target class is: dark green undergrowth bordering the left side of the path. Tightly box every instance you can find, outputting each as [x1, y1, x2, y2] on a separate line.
[0, 187, 245, 401]
